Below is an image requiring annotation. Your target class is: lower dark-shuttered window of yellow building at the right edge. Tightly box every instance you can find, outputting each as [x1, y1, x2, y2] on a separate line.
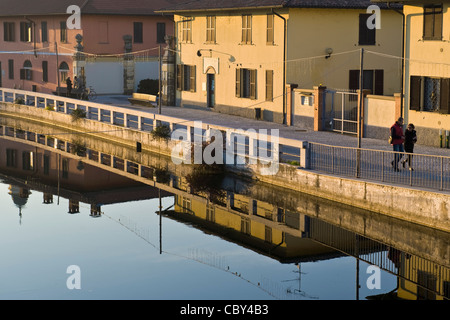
[409, 76, 450, 114]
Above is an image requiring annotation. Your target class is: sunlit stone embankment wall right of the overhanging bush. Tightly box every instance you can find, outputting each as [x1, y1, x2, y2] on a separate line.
[243, 164, 450, 232]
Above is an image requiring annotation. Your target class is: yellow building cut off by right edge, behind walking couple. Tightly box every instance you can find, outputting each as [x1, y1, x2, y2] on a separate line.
[373, 0, 450, 147]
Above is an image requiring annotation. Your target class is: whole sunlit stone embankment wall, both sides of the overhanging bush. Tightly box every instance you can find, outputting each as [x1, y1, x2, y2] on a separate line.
[0, 103, 450, 232]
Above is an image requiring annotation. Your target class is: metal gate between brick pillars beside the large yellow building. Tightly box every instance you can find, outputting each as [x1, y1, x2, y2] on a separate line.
[322, 89, 358, 134]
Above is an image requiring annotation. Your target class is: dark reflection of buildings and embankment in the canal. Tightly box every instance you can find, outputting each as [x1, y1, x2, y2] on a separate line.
[0, 120, 450, 300]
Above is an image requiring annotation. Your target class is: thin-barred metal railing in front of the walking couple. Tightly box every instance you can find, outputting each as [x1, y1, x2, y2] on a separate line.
[309, 142, 450, 191]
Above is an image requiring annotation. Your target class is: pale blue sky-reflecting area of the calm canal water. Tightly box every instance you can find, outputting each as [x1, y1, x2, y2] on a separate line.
[0, 183, 397, 300]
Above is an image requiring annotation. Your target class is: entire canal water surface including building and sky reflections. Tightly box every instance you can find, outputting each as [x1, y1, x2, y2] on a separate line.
[0, 118, 450, 301]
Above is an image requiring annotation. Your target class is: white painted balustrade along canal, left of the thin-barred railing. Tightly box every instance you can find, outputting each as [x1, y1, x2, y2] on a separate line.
[0, 88, 308, 167]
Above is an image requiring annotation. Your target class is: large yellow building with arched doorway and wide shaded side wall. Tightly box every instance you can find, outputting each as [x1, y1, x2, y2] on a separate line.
[160, 0, 402, 124]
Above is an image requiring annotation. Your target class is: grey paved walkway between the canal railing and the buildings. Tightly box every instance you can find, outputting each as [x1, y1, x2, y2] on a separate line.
[95, 95, 450, 156]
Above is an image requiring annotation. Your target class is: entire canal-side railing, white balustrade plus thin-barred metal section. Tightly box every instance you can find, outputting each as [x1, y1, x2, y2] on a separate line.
[0, 88, 450, 191]
